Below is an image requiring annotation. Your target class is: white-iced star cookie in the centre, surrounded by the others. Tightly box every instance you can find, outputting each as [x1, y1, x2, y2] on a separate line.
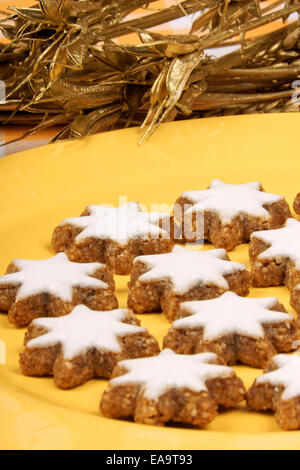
[128, 246, 250, 320]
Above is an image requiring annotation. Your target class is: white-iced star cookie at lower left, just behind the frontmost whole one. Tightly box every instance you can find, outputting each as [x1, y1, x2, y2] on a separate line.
[20, 305, 159, 388]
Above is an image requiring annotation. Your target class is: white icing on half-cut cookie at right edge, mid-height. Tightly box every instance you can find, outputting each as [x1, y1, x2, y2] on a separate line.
[251, 218, 300, 269]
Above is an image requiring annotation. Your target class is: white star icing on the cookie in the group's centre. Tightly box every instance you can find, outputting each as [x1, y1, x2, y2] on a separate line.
[134, 246, 247, 294]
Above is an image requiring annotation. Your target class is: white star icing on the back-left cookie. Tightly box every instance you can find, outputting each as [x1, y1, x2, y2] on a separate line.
[60, 201, 170, 245]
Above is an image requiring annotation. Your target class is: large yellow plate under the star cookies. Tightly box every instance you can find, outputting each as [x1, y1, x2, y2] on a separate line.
[0, 114, 300, 449]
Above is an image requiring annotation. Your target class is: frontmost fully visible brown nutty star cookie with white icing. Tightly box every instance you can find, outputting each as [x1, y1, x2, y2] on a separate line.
[100, 349, 245, 426]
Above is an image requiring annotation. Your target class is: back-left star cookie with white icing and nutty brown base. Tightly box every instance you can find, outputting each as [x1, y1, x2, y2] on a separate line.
[52, 202, 174, 274]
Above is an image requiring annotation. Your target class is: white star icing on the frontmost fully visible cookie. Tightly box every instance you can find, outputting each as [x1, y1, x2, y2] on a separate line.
[110, 349, 234, 400]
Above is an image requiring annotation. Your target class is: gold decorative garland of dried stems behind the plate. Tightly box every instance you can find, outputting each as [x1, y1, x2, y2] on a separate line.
[0, 0, 300, 141]
